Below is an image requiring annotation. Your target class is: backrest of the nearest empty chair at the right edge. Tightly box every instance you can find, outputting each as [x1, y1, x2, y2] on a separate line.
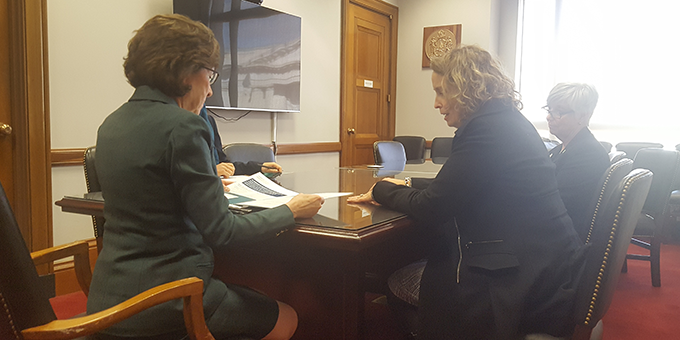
[633, 148, 680, 218]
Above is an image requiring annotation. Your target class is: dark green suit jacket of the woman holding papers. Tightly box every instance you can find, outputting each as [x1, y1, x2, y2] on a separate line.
[87, 86, 295, 336]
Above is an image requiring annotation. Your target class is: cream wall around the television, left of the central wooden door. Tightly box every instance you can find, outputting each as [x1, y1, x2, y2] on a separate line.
[47, 0, 341, 245]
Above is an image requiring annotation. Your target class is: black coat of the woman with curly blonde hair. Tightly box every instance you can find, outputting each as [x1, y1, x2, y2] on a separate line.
[373, 100, 580, 339]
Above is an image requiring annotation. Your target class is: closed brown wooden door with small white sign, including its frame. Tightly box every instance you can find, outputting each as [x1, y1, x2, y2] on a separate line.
[340, 0, 398, 166]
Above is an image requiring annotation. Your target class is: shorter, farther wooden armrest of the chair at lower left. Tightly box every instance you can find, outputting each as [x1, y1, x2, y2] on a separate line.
[31, 241, 92, 295]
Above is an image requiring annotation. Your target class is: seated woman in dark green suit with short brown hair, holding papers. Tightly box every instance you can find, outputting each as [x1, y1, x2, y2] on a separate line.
[87, 15, 323, 339]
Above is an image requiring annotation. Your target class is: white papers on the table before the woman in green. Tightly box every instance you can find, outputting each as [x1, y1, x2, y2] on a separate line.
[224, 172, 352, 208]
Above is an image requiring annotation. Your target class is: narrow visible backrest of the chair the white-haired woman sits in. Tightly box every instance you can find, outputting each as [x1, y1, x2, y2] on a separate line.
[577, 158, 633, 243]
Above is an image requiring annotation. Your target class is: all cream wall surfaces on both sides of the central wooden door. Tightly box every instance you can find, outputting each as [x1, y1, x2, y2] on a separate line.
[47, 0, 516, 244]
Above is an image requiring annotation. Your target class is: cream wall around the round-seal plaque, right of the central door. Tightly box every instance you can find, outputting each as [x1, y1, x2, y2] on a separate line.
[396, 0, 517, 140]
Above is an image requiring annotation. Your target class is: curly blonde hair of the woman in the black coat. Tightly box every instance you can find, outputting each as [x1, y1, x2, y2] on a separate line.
[430, 46, 522, 119]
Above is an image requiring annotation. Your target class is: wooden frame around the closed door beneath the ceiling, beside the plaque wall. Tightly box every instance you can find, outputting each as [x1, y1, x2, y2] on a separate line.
[340, 0, 399, 166]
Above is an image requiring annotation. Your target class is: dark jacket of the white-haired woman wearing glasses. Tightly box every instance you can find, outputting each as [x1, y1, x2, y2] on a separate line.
[550, 128, 609, 242]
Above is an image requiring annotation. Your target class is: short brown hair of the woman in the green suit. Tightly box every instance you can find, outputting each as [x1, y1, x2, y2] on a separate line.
[123, 14, 220, 98]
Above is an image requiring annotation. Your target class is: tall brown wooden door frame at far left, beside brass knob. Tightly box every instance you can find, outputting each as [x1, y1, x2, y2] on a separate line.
[8, 0, 53, 251]
